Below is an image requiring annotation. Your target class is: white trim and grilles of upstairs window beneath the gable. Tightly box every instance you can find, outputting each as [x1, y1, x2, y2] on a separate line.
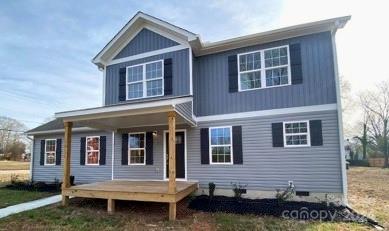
[126, 59, 165, 100]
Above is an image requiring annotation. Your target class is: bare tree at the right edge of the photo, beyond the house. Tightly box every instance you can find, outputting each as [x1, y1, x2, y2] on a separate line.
[361, 81, 389, 168]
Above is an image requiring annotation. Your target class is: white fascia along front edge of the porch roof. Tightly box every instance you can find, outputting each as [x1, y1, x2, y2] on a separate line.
[55, 97, 192, 121]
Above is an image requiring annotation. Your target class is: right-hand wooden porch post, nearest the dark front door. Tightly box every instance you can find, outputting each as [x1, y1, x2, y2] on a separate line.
[168, 111, 176, 220]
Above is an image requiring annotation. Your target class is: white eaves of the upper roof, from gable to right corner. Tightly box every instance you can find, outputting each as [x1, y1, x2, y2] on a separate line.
[92, 11, 351, 67]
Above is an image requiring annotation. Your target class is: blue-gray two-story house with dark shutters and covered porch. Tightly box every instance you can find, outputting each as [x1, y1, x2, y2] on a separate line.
[28, 12, 350, 215]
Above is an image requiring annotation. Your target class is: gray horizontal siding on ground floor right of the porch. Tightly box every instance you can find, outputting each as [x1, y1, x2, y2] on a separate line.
[187, 111, 342, 193]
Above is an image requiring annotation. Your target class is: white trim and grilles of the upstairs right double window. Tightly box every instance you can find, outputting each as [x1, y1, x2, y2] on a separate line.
[237, 45, 292, 92]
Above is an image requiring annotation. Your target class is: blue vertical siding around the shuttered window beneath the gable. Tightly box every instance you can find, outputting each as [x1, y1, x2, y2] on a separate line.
[105, 49, 190, 105]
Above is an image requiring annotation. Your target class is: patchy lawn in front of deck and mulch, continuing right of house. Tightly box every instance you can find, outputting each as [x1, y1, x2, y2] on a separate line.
[0, 168, 389, 230]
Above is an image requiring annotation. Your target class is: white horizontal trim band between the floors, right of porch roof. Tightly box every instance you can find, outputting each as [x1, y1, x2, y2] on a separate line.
[197, 103, 337, 122]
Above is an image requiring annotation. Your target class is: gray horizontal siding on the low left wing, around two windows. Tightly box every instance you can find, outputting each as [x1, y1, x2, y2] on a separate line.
[32, 132, 112, 184]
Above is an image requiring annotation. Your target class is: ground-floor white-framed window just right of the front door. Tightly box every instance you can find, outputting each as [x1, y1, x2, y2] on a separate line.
[209, 126, 233, 164]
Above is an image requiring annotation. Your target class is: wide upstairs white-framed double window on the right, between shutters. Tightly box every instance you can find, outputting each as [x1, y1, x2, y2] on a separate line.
[238, 45, 291, 91]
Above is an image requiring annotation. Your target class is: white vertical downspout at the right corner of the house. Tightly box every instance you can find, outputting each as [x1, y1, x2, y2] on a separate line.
[331, 28, 348, 204]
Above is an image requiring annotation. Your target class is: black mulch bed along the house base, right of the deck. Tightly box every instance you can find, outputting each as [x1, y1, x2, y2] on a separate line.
[189, 195, 378, 225]
